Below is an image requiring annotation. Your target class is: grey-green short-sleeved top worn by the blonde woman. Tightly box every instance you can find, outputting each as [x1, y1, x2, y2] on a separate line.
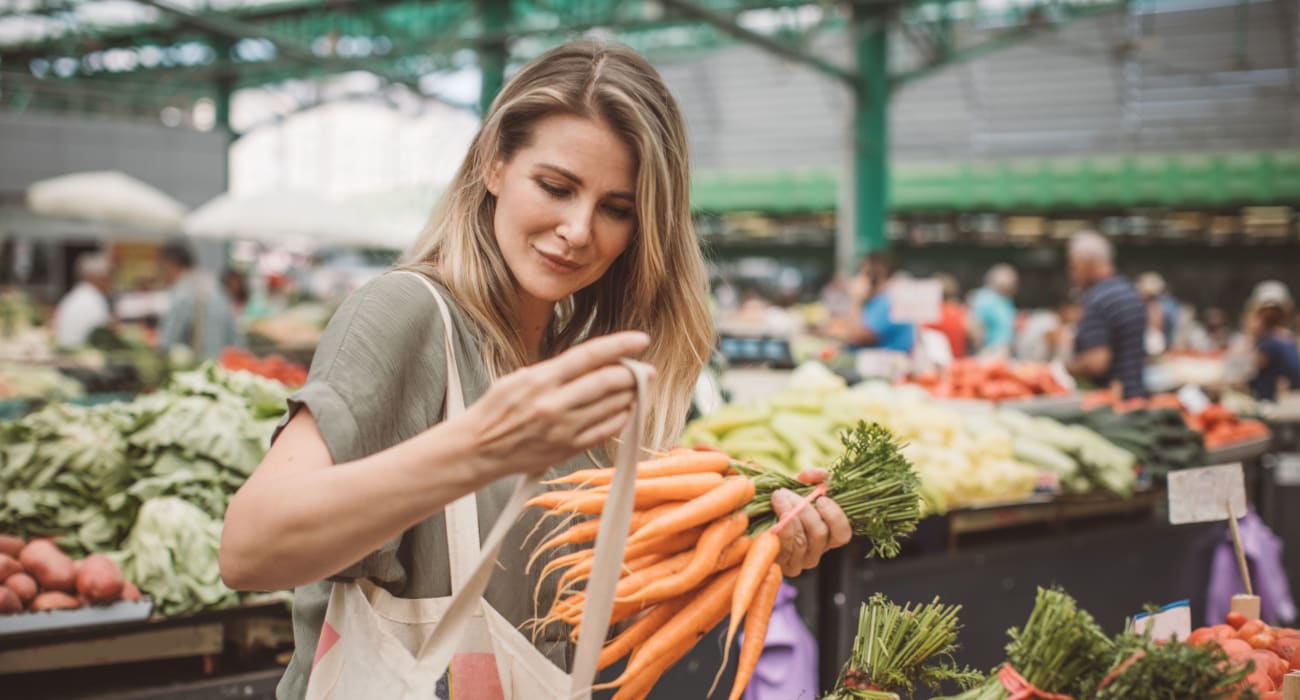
[276, 272, 592, 700]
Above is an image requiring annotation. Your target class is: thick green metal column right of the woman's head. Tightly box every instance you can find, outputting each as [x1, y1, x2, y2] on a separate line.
[853, 4, 889, 255]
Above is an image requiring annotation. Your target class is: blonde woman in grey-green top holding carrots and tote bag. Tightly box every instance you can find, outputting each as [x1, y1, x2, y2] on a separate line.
[221, 42, 850, 697]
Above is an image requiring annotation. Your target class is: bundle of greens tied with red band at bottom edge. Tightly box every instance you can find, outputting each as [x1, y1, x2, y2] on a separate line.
[949, 588, 1114, 700]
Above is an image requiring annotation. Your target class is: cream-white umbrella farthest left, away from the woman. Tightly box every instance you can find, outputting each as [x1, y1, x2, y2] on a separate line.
[27, 170, 186, 230]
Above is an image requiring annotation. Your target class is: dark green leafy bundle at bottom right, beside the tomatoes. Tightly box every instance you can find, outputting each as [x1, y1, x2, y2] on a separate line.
[1095, 634, 1256, 700]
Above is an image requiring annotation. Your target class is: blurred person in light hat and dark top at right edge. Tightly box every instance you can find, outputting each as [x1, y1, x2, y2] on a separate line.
[1245, 280, 1300, 401]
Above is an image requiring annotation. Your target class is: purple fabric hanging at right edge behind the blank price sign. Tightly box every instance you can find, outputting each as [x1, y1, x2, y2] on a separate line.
[1205, 510, 1296, 625]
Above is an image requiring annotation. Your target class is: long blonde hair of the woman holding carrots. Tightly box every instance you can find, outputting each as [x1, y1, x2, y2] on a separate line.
[403, 42, 714, 448]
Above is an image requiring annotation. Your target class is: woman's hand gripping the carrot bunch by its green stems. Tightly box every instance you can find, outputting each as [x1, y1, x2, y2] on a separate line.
[772, 470, 853, 576]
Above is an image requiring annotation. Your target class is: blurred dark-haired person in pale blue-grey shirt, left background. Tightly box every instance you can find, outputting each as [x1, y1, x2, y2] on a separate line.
[159, 241, 243, 359]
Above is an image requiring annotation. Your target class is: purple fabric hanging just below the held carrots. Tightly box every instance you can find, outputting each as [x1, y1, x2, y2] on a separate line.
[732, 582, 818, 700]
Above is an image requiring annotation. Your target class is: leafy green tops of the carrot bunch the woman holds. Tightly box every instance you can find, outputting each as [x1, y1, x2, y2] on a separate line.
[737, 420, 920, 558]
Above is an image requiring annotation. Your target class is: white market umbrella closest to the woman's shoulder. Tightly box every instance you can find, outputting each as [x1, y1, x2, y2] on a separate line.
[183, 191, 368, 245]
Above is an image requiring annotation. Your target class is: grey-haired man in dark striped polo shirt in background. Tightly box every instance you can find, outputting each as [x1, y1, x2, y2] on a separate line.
[1067, 232, 1147, 398]
